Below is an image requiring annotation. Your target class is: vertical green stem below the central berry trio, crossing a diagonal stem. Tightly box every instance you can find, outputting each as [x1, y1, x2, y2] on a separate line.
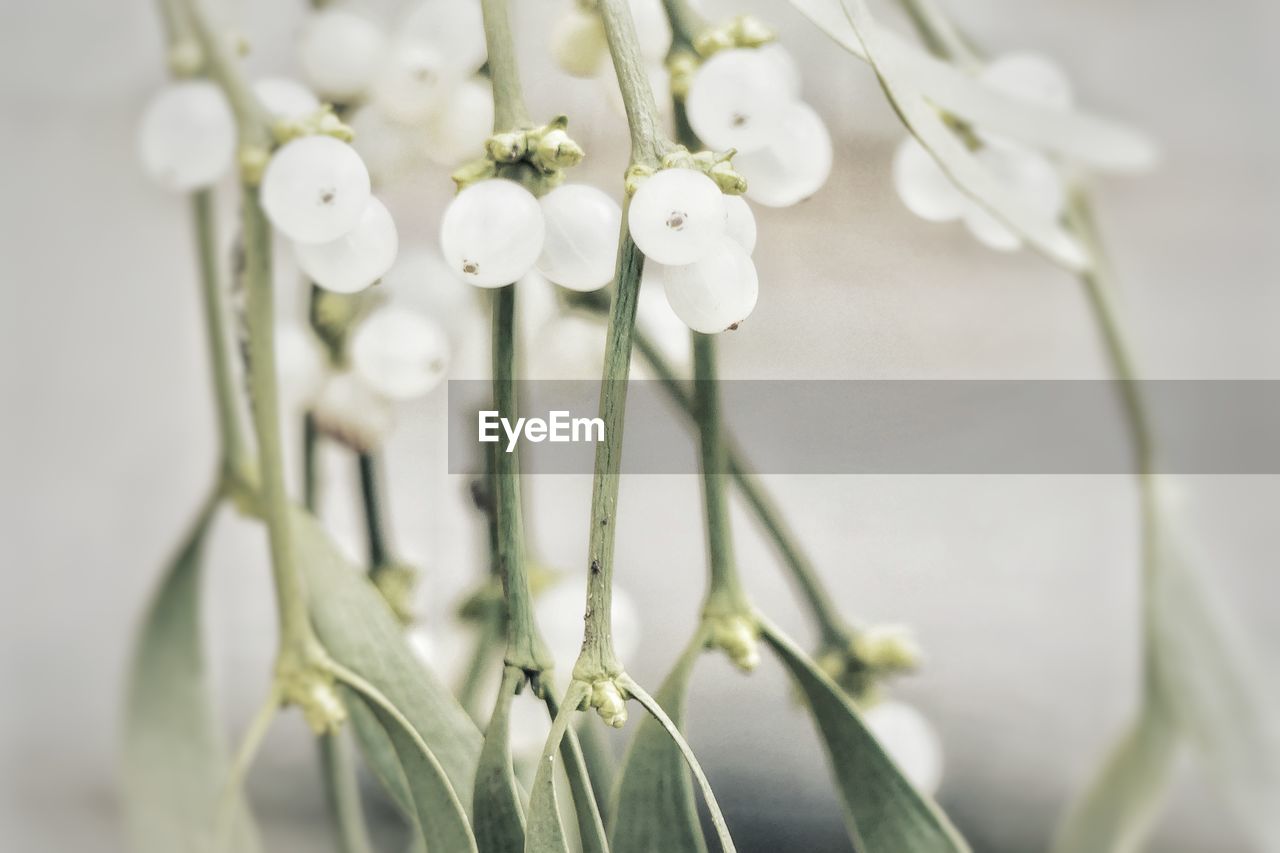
[691, 332, 750, 615]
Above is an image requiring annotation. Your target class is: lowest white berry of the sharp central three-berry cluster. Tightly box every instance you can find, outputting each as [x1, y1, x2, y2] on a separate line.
[660, 237, 759, 334]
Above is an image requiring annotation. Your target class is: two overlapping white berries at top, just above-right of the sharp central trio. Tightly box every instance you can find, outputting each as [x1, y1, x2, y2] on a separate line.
[685, 41, 832, 207]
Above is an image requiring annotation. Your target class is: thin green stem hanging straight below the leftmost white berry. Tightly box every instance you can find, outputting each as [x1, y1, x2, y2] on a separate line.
[191, 190, 250, 483]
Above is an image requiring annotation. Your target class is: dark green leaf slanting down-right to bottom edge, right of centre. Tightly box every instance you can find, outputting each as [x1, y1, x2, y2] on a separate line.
[759, 619, 969, 853]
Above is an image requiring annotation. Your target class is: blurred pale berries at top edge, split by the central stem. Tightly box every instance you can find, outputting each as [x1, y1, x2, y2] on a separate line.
[550, 0, 671, 123]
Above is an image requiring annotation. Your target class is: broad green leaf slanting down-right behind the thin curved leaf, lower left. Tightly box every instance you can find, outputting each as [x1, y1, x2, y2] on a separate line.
[291, 507, 481, 803]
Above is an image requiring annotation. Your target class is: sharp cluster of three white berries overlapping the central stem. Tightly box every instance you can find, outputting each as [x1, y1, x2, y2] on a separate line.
[627, 164, 759, 334]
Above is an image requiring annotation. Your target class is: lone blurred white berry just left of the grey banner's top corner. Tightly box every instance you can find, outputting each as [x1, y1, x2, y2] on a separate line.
[349, 305, 449, 400]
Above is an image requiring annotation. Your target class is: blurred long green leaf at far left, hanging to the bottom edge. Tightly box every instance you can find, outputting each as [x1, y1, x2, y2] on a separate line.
[123, 496, 260, 853]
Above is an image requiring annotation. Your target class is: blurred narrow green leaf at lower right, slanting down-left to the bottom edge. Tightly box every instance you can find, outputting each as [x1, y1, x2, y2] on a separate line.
[1053, 698, 1178, 853]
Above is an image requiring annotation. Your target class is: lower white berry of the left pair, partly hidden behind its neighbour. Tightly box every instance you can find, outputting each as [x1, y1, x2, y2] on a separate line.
[294, 196, 399, 293]
